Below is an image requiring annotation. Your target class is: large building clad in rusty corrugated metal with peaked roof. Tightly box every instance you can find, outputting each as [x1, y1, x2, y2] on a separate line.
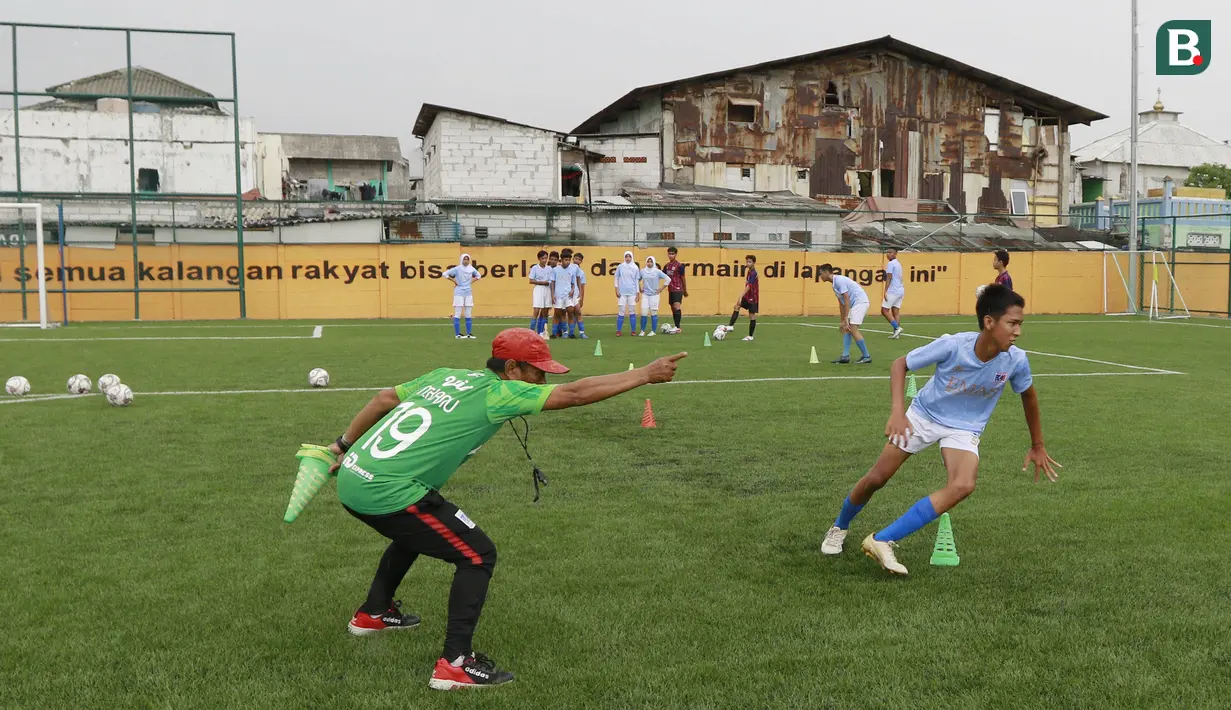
[574, 37, 1107, 224]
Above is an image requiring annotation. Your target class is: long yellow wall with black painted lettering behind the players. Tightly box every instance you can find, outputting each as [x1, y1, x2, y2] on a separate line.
[0, 245, 1152, 322]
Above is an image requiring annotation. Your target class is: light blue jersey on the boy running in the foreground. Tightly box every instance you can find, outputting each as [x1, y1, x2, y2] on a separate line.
[906, 332, 1034, 434]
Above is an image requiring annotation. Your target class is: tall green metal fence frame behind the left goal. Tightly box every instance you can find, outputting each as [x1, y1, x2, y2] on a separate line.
[0, 22, 247, 320]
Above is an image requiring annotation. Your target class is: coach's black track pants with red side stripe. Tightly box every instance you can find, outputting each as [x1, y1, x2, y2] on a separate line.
[346, 491, 496, 661]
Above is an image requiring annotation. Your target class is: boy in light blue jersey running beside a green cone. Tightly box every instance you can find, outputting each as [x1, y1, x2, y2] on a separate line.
[821, 285, 1062, 575]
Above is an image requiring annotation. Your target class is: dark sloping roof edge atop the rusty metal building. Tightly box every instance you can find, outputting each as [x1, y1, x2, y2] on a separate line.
[574, 34, 1107, 134]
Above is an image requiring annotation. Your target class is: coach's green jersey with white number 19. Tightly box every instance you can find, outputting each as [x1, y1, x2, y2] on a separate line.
[337, 368, 555, 516]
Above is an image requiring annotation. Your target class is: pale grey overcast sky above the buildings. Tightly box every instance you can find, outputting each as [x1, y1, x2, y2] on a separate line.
[0, 0, 1231, 172]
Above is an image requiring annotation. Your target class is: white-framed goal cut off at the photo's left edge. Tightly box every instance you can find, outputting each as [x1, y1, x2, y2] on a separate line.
[0, 203, 59, 329]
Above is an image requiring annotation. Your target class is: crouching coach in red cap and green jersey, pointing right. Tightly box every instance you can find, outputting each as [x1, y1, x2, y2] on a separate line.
[330, 329, 687, 690]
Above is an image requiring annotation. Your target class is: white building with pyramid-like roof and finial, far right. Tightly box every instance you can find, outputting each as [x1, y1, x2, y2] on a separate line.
[1072, 100, 1231, 203]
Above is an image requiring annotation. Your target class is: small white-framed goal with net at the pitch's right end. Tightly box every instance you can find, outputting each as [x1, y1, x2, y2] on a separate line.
[1103, 246, 1192, 320]
